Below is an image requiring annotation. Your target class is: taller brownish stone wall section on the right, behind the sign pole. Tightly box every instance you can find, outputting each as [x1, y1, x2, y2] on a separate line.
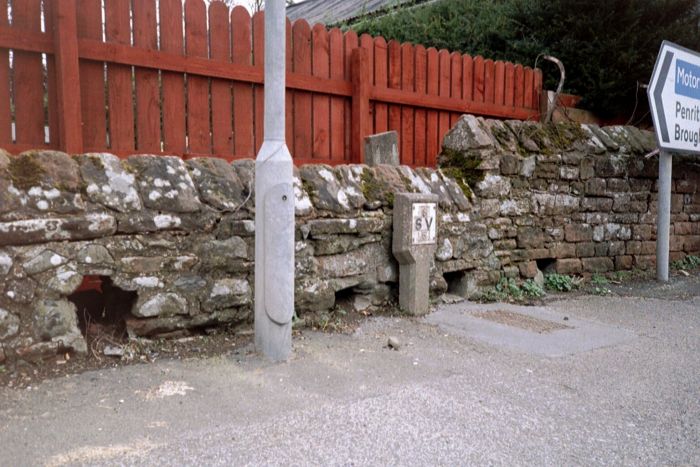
[440, 116, 700, 278]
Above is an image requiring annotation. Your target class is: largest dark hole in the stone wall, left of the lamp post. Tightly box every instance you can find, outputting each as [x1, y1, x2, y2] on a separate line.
[68, 276, 138, 346]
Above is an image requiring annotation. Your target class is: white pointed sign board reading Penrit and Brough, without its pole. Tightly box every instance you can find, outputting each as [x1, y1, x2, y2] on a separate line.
[647, 41, 700, 154]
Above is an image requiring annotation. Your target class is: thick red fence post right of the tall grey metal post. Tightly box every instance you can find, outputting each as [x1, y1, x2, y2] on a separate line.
[351, 47, 372, 164]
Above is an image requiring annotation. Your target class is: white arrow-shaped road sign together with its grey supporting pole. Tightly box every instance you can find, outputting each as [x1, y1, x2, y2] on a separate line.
[647, 41, 700, 282]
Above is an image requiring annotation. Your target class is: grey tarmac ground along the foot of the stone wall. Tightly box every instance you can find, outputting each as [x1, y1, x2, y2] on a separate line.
[0, 282, 700, 466]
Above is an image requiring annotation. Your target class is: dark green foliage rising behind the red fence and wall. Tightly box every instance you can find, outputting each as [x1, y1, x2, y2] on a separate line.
[350, 0, 700, 117]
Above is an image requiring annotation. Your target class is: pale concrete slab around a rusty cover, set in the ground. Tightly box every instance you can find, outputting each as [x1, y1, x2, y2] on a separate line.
[425, 302, 637, 357]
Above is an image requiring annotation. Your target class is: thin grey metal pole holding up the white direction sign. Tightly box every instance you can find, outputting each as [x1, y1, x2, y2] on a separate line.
[656, 151, 673, 282]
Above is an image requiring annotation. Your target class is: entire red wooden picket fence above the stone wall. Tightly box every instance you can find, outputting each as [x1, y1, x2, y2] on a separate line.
[0, 0, 542, 166]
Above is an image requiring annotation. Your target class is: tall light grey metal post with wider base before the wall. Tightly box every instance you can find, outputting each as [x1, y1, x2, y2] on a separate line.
[255, 0, 294, 361]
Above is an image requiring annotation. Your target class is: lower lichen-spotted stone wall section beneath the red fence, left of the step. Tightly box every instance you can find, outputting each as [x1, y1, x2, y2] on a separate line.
[0, 151, 490, 360]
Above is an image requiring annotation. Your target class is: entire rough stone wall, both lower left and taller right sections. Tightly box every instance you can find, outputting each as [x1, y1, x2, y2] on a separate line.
[0, 116, 700, 361]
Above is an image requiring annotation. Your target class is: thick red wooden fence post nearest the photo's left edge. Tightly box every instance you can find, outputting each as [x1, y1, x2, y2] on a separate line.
[51, 0, 83, 154]
